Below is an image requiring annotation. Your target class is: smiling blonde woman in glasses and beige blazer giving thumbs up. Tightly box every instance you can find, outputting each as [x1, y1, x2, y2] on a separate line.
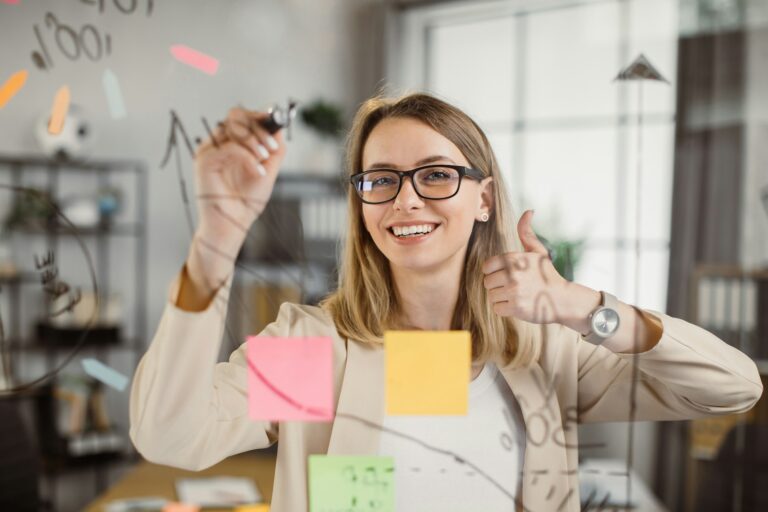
[131, 94, 762, 512]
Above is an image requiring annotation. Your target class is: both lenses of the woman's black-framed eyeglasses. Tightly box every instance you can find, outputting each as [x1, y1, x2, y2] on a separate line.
[357, 167, 461, 203]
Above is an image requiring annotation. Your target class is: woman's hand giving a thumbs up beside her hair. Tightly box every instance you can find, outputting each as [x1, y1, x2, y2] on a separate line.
[482, 210, 568, 324]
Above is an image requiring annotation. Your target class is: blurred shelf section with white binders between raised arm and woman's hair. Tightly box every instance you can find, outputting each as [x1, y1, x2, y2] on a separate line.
[228, 172, 347, 348]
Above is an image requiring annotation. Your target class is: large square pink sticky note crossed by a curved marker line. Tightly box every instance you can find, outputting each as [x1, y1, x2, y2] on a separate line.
[248, 336, 333, 421]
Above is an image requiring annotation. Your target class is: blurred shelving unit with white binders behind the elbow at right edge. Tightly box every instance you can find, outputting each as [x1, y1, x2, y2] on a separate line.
[687, 264, 768, 510]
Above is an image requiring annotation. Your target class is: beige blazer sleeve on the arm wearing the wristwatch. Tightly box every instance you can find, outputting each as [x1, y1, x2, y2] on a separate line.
[573, 310, 763, 423]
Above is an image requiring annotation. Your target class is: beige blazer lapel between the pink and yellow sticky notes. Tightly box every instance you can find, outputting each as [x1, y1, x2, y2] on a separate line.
[328, 340, 385, 455]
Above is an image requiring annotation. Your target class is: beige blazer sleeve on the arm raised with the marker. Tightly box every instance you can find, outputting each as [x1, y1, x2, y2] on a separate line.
[130, 270, 295, 471]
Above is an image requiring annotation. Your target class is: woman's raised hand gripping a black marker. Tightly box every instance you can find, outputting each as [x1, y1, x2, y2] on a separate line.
[195, 108, 285, 259]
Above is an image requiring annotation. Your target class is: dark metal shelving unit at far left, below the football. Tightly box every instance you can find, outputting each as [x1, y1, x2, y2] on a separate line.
[0, 155, 148, 509]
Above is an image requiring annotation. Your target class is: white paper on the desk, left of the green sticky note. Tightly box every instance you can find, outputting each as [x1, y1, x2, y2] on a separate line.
[176, 476, 263, 508]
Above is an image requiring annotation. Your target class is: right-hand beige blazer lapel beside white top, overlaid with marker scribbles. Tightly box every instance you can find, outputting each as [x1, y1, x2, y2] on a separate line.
[502, 363, 573, 512]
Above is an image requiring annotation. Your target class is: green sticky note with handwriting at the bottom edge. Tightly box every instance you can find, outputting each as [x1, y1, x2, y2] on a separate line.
[309, 455, 395, 512]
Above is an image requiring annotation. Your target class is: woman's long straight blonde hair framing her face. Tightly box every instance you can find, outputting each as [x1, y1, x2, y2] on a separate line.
[320, 93, 541, 367]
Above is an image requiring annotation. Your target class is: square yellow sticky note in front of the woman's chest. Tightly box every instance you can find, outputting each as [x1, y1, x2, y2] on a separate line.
[384, 331, 472, 415]
